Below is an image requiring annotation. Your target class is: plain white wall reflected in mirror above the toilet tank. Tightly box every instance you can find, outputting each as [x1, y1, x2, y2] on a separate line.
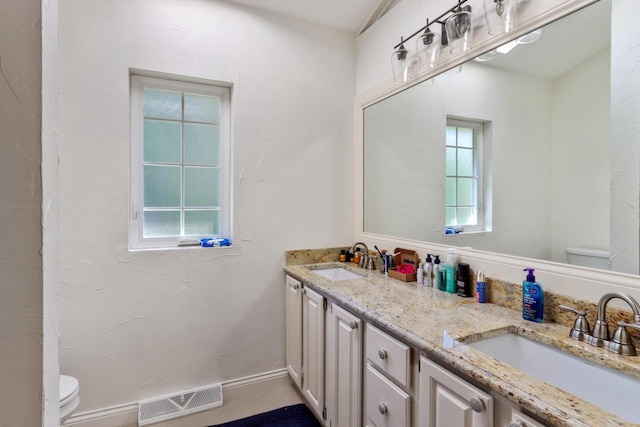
[550, 49, 608, 264]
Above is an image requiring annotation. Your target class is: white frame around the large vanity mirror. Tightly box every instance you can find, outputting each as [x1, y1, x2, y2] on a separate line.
[353, 0, 640, 289]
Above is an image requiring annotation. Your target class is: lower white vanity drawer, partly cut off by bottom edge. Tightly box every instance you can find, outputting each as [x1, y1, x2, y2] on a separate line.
[365, 363, 411, 427]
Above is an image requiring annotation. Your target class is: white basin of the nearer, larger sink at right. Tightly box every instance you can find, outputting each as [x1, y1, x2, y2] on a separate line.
[469, 334, 640, 423]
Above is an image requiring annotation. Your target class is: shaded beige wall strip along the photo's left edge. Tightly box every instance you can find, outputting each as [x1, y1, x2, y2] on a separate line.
[0, 0, 43, 427]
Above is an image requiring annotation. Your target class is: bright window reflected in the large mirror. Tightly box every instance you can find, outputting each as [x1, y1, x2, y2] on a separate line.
[445, 118, 484, 231]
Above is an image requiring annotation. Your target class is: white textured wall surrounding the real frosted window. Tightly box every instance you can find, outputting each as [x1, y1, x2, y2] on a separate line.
[59, 0, 355, 411]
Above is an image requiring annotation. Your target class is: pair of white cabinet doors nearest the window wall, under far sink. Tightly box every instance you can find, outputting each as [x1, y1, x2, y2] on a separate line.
[285, 276, 326, 418]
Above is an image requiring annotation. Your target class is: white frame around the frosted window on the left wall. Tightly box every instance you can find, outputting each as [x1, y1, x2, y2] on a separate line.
[129, 73, 233, 250]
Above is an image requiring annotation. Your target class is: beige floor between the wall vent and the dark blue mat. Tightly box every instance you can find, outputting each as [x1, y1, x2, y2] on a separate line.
[154, 381, 303, 427]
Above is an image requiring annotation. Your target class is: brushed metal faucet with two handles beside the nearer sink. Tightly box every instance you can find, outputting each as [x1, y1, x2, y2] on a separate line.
[560, 292, 640, 356]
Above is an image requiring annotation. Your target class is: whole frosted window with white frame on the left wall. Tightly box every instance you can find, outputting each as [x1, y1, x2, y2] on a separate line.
[129, 75, 231, 249]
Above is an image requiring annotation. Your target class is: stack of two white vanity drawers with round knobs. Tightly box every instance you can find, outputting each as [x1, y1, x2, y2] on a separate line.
[364, 324, 411, 427]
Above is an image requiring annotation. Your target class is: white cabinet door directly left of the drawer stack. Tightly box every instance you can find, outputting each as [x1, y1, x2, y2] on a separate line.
[326, 304, 362, 427]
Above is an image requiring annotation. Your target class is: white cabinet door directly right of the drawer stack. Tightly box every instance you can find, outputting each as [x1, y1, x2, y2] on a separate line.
[419, 357, 493, 427]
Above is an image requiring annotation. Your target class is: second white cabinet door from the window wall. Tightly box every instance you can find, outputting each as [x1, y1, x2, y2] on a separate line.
[302, 288, 325, 417]
